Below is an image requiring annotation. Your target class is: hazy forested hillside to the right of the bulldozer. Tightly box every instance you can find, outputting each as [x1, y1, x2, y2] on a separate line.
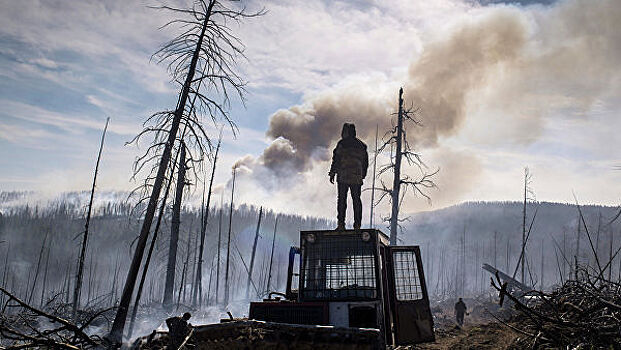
[400, 202, 621, 297]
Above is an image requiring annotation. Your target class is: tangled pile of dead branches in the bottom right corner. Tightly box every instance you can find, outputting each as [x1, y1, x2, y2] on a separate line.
[492, 268, 621, 349]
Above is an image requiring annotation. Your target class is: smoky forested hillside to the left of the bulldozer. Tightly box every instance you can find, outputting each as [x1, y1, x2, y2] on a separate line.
[0, 197, 333, 314]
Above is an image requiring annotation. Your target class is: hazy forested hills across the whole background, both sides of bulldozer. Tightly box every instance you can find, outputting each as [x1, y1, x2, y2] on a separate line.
[0, 192, 621, 305]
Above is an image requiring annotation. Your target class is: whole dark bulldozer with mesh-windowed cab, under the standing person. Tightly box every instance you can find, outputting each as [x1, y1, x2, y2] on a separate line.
[132, 229, 435, 350]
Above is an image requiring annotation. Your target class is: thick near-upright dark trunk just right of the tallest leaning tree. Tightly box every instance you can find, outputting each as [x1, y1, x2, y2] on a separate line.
[162, 143, 186, 311]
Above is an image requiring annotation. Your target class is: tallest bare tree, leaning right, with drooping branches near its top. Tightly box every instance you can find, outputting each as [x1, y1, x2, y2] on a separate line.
[108, 0, 263, 344]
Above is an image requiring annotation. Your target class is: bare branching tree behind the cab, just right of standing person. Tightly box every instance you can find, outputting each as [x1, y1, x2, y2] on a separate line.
[378, 88, 440, 245]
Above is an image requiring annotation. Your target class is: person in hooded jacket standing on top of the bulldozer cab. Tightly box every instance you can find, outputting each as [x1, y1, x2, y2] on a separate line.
[328, 123, 369, 231]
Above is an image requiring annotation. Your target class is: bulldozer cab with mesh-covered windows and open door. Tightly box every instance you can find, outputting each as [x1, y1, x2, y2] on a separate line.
[285, 229, 435, 345]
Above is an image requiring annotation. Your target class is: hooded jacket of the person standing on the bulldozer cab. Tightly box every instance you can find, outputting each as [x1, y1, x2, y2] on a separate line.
[329, 123, 369, 185]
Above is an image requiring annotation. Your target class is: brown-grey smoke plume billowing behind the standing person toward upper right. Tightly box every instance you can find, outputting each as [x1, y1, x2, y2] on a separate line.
[230, 0, 621, 216]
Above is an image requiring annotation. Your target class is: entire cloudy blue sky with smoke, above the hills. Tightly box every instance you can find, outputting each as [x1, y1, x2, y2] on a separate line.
[0, 0, 621, 219]
